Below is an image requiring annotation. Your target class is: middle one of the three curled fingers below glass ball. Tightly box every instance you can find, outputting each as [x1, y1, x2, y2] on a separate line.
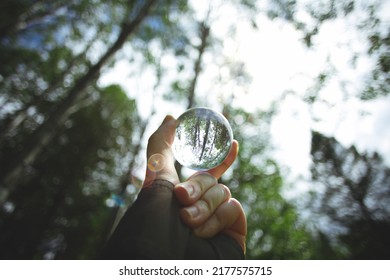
[180, 184, 231, 228]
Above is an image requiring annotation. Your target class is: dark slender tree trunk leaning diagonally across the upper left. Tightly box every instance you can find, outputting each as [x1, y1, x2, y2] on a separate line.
[0, 0, 156, 205]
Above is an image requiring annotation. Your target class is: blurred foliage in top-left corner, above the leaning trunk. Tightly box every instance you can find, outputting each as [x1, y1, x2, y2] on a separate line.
[0, 0, 123, 123]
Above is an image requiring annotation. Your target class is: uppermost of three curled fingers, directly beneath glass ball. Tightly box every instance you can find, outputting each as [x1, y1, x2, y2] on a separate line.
[174, 172, 218, 206]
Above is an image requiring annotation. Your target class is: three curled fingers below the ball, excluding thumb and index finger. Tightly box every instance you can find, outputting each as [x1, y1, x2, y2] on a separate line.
[174, 172, 246, 253]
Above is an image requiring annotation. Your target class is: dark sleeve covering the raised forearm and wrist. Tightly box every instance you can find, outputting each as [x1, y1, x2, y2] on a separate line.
[100, 180, 244, 259]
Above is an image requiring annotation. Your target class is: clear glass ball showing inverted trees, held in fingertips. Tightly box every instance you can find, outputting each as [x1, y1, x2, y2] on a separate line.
[172, 108, 233, 170]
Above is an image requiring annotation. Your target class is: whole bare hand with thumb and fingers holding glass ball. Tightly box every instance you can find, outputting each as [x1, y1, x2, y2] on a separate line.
[144, 116, 246, 252]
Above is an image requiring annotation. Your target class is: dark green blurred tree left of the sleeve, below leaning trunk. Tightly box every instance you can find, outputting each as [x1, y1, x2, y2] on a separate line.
[0, 86, 136, 259]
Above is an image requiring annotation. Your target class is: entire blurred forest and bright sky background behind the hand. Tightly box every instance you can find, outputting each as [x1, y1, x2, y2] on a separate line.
[0, 0, 390, 259]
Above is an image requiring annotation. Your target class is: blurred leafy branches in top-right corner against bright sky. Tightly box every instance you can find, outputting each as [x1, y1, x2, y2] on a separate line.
[298, 0, 390, 105]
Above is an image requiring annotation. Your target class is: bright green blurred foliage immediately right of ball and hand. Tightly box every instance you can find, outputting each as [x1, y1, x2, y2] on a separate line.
[223, 106, 315, 259]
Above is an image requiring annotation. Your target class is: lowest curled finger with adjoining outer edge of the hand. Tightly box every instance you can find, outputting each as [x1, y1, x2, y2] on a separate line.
[194, 198, 247, 253]
